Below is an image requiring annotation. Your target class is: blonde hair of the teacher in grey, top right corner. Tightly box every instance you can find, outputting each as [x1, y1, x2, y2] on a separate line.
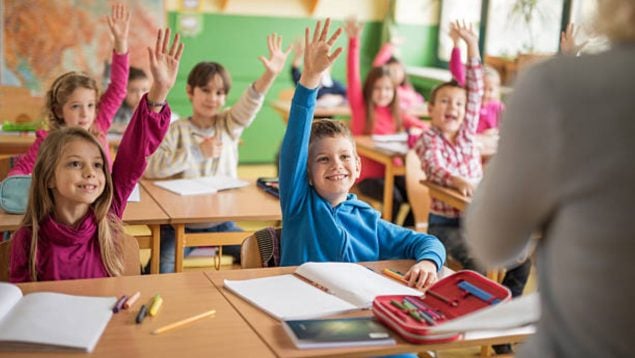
[595, 0, 635, 42]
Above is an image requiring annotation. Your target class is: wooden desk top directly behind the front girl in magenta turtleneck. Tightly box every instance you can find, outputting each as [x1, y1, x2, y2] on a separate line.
[0, 185, 169, 231]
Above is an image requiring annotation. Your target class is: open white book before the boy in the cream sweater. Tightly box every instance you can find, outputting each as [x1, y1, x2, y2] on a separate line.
[154, 175, 249, 195]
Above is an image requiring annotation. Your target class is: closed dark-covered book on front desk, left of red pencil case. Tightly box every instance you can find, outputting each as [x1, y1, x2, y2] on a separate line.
[282, 317, 396, 349]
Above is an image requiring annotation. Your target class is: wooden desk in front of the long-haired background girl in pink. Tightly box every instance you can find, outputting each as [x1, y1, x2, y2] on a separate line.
[355, 136, 406, 221]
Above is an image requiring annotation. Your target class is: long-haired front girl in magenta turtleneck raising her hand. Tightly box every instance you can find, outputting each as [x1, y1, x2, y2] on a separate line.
[9, 29, 183, 282]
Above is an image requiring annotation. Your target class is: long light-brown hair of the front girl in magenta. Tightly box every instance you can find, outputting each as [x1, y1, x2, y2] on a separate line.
[21, 127, 124, 281]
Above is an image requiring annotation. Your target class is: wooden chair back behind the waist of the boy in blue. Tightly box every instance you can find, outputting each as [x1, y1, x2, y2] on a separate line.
[240, 226, 282, 268]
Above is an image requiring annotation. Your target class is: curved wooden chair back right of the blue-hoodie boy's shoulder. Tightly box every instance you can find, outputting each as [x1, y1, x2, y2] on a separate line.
[406, 149, 430, 232]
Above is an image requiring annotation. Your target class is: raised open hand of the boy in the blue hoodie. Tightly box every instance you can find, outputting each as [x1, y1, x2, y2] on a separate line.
[300, 18, 342, 88]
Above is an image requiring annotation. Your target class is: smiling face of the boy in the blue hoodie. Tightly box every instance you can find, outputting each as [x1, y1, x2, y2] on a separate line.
[308, 135, 361, 206]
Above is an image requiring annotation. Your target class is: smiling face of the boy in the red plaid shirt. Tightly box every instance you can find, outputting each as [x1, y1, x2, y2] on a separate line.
[428, 86, 467, 140]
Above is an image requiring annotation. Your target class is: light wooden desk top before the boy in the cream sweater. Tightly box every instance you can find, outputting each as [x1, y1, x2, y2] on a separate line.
[142, 180, 282, 224]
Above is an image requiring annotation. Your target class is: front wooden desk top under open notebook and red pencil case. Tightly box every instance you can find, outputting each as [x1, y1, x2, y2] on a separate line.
[205, 260, 530, 357]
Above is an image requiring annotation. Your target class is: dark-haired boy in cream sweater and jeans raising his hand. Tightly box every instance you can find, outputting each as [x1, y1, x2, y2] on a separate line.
[145, 34, 290, 272]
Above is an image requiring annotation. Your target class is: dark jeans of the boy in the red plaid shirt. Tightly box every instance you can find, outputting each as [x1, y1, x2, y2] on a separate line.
[428, 214, 531, 297]
